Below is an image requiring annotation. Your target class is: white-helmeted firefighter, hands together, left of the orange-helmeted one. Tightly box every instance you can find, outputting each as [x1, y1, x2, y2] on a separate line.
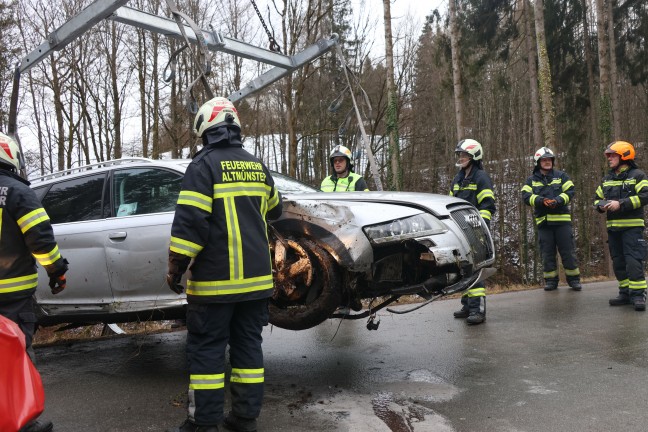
[522, 147, 582, 291]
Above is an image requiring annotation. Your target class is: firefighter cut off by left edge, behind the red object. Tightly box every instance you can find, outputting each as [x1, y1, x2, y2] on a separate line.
[0, 133, 68, 432]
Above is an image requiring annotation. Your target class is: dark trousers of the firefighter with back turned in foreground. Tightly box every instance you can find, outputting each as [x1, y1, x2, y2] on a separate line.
[187, 299, 268, 426]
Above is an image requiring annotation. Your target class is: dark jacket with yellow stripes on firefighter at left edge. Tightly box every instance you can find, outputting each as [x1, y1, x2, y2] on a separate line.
[0, 168, 67, 302]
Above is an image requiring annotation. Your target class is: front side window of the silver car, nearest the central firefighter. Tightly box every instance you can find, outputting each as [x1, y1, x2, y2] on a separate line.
[112, 168, 182, 217]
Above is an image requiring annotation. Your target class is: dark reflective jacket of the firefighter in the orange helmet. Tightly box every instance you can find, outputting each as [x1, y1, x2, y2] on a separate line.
[594, 164, 648, 231]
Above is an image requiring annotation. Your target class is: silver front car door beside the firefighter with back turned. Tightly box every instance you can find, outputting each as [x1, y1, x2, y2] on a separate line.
[106, 167, 185, 312]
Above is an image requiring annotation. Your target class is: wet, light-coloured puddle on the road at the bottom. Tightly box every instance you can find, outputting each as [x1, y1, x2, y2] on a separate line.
[306, 370, 459, 432]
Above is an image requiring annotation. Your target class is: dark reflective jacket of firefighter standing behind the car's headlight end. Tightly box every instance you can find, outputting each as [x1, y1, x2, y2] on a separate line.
[450, 164, 495, 226]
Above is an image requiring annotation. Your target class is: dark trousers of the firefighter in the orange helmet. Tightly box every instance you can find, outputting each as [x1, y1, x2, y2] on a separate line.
[608, 227, 647, 297]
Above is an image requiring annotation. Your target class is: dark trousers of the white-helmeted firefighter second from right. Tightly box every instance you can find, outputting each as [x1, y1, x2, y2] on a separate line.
[538, 224, 580, 284]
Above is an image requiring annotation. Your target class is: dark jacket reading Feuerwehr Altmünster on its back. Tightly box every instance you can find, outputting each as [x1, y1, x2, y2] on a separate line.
[170, 145, 281, 303]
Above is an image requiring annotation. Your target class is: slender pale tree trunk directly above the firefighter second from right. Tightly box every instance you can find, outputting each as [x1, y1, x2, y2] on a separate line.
[534, 0, 558, 152]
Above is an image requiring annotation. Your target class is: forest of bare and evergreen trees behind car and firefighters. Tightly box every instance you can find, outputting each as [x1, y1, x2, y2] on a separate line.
[0, 0, 648, 284]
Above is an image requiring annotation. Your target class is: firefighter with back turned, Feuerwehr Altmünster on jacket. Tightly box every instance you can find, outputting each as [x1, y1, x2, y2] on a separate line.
[167, 97, 281, 432]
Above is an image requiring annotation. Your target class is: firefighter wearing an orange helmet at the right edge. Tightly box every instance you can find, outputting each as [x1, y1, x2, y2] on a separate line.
[594, 141, 648, 311]
